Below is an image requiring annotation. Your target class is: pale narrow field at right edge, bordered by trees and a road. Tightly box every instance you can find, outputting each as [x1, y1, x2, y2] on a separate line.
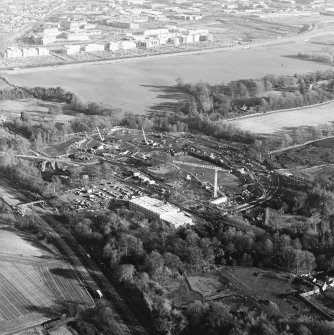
[229, 103, 334, 135]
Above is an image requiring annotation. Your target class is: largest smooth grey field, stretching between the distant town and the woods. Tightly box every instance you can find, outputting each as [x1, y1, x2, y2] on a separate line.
[6, 42, 331, 114]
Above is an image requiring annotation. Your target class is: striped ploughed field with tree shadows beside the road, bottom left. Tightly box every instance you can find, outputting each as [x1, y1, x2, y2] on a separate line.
[0, 230, 93, 334]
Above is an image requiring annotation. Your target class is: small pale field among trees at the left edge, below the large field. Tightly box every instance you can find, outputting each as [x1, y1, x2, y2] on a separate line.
[0, 99, 73, 122]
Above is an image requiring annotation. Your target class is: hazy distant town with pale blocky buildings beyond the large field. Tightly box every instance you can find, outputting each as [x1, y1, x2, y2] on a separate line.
[0, 0, 334, 69]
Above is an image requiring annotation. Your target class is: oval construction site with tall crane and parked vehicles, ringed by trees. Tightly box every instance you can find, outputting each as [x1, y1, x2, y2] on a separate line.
[7, 127, 278, 227]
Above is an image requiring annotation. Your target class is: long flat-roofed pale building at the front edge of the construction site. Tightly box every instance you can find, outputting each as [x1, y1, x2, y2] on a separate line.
[129, 196, 193, 228]
